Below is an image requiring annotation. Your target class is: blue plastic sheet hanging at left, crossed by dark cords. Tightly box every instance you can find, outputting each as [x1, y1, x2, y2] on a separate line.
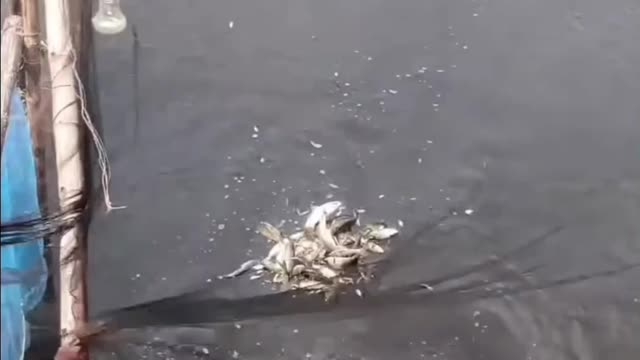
[1, 95, 47, 360]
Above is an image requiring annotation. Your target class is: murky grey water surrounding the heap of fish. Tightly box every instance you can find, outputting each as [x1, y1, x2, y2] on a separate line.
[27, 0, 640, 360]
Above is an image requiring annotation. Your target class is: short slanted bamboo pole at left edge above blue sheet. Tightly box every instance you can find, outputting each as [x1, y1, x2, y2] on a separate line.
[0, 15, 22, 156]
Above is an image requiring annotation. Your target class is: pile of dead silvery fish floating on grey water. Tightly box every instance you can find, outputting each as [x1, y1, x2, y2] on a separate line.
[219, 201, 398, 298]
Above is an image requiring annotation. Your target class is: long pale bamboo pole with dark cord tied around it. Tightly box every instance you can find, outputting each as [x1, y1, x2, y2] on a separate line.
[44, 0, 88, 358]
